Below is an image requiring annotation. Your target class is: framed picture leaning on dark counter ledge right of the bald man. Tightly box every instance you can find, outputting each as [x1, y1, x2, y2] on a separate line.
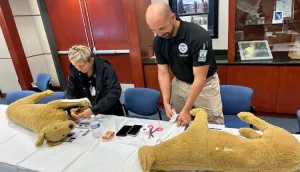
[238, 41, 273, 60]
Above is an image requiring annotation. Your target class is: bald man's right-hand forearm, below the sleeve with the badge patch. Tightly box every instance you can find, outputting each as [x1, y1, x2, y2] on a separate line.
[183, 78, 206, 112]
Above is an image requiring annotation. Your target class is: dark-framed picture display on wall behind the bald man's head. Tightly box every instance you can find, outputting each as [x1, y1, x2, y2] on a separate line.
[169, 0, 219, 38]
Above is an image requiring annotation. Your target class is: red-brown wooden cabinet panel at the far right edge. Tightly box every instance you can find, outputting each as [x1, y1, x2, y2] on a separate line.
[276, 66, 300, 114]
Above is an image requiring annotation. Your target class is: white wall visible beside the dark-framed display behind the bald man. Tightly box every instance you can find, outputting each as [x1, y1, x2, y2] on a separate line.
[151, 0, 229, 50]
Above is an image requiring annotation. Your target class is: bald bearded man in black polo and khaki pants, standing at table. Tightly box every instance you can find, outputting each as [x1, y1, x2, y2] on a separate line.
[146, 3, 224, 126]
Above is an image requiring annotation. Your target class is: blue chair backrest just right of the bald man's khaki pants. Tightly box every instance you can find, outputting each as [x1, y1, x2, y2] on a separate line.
[220, 85, 253, 115]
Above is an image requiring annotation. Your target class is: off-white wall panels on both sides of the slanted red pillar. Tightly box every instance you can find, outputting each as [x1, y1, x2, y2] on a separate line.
[0, 0, 59, 93]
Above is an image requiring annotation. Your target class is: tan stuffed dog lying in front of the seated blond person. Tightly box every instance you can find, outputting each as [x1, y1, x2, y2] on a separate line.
[6, 90, 89, 146]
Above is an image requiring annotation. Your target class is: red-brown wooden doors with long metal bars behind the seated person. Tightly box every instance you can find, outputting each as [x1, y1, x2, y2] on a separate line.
[45, 0, 153, 87]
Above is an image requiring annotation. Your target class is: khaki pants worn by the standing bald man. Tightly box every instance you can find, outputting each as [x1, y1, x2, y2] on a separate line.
[171, 73, 224, 124]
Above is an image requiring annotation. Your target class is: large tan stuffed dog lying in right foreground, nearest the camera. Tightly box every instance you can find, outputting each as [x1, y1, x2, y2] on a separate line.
[139, 108, 300, 172]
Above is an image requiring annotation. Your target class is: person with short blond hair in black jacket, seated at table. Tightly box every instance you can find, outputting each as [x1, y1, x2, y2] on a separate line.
[66, 45, 124, 119]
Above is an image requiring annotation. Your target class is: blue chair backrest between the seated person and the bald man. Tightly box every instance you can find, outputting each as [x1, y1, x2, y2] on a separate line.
[124, 88, 160, 116]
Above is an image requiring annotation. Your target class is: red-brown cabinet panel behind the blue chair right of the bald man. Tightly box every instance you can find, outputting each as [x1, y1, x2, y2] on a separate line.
[227, 66, 279, 112]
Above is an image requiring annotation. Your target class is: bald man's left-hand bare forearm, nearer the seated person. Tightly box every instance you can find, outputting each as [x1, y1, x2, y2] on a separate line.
[158, 73, 171, 104]
